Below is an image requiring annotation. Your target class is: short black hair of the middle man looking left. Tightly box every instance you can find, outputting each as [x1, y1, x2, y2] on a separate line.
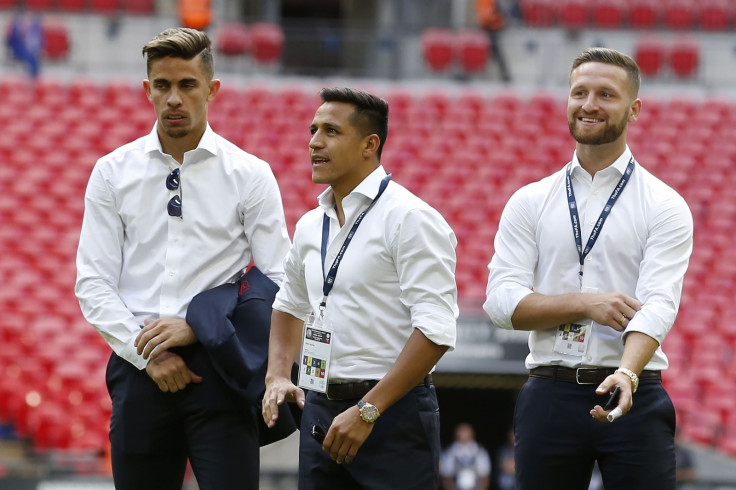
[319, 87, 388, 161]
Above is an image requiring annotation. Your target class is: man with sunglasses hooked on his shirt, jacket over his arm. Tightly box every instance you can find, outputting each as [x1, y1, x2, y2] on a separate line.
[75, 28, 290, 490]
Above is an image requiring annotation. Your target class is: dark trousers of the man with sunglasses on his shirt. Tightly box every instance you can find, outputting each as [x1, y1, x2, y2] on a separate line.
[107, 348, 260, 490]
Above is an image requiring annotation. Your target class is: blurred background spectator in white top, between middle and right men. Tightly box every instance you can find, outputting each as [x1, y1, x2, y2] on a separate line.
[440, 423, 491, 490]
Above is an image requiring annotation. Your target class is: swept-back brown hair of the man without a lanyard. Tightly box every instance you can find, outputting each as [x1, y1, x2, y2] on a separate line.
[143, 27, 215, 80]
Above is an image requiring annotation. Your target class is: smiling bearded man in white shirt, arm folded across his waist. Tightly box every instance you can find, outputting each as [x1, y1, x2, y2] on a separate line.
[484, 48, 693, 490]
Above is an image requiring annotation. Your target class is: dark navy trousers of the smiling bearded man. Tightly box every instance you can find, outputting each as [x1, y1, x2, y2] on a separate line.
[514, 377, 675, 490]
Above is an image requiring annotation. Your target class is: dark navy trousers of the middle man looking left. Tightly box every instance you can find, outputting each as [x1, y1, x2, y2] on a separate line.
[299, 385, 441, 490]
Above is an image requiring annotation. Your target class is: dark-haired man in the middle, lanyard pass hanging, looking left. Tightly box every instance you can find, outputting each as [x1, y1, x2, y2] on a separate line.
[263, 88, 458, 490]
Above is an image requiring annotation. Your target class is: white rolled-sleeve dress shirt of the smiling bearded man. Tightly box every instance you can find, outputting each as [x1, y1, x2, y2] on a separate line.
[483, 146, 693, 370]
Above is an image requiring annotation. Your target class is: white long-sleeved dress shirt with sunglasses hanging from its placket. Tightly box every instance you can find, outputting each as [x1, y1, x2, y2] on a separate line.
[75, 125, 290, 369]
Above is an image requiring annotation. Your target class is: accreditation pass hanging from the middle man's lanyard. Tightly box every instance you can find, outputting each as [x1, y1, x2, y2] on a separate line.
[299, 315, 334, 393]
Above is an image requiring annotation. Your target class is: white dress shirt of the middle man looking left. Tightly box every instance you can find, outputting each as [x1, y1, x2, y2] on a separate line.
[274, 167, 458, 382]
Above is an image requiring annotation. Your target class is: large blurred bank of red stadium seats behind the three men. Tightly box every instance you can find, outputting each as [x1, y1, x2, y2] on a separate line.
[0, 79, 736, 458]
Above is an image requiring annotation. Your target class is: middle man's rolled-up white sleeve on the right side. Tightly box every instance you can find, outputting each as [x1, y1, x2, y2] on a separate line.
[391, 207, 459, 349]
